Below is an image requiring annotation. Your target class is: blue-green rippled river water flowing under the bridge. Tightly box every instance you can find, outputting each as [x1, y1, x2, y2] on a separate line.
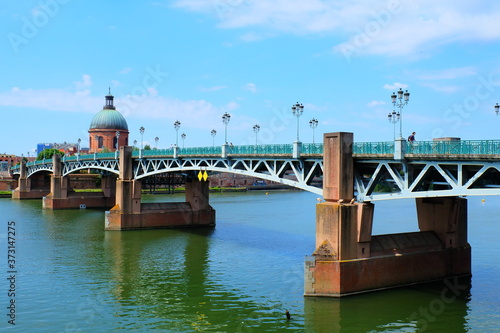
[0, 191, 500, 332]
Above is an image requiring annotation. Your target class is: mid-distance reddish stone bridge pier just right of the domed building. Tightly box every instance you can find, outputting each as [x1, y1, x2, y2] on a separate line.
[105, 146, 215, 230]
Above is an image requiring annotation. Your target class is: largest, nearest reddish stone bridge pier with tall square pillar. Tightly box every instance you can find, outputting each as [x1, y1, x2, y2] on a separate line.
[304, 133, 471, 297]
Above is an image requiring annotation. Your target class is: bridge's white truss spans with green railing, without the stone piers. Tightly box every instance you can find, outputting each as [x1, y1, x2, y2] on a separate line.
[12, 140, 500, 202]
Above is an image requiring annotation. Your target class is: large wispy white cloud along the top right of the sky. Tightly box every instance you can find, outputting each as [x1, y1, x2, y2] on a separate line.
[173, 0, 500, 57]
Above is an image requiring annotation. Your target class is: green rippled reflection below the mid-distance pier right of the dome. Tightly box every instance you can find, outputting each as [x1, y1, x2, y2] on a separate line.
[101, 229, 298, 332]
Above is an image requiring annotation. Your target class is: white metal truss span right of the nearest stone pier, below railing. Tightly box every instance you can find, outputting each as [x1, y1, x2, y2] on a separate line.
[354, 159, 500, 202]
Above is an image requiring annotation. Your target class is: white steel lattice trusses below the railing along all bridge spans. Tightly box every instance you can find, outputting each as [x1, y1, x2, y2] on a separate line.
[16, 155, 500, 202]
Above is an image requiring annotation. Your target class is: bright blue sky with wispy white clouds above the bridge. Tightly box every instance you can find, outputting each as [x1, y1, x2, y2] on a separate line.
[0, 0, 500, 156]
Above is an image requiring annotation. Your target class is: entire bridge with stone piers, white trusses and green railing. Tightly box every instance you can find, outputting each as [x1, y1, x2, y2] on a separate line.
[8, 132, 500, 297]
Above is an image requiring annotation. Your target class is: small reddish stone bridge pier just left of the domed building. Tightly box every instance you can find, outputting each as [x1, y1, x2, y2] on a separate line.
[42, 154, 115, 209]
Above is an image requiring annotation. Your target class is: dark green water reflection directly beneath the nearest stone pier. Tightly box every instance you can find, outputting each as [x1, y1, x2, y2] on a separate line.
[304, 278, 471, 333]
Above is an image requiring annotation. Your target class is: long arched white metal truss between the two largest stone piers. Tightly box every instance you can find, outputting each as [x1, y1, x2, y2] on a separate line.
[134, 157, 323, 195]
